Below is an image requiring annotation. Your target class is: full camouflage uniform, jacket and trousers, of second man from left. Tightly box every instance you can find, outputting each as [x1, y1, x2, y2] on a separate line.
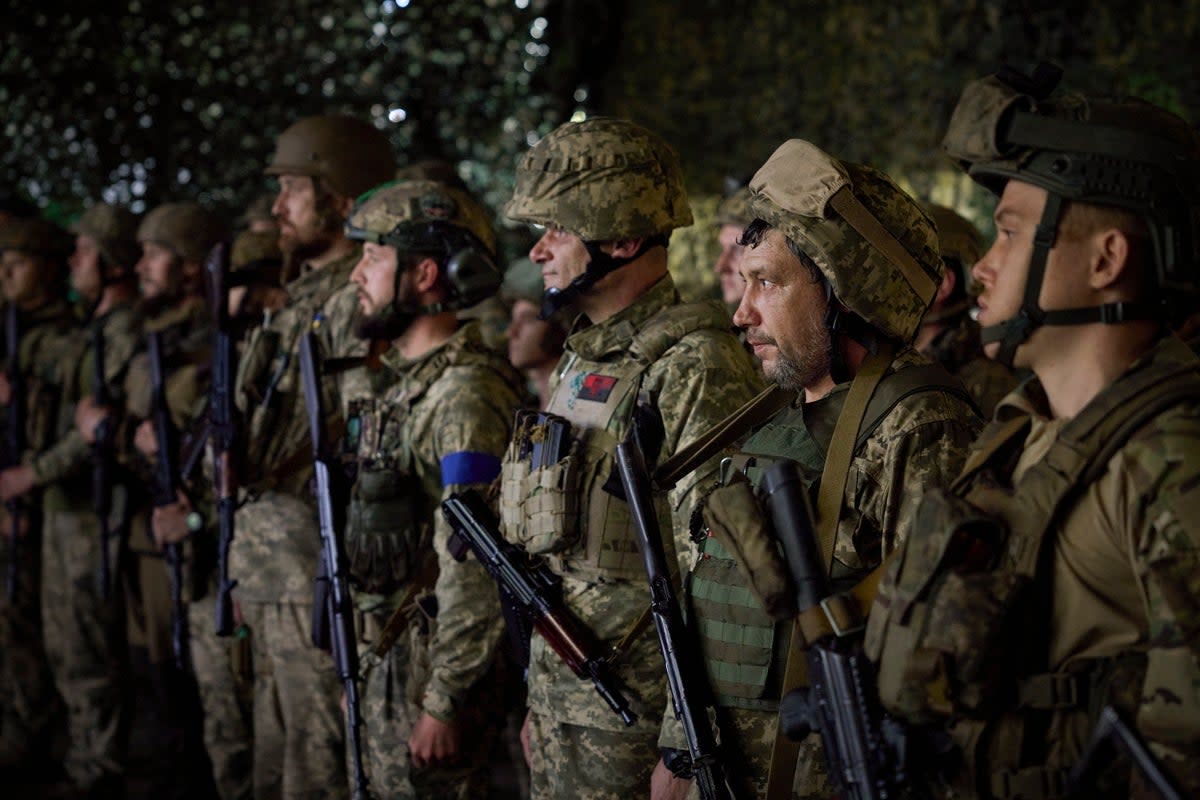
[34, 298, 142, 784]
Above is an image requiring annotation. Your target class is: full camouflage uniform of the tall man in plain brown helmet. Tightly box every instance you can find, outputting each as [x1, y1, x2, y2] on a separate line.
[229, 251, 365, 798]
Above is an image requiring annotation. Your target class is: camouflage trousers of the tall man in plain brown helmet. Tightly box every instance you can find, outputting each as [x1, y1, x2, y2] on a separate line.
[241, 602, 348, 800]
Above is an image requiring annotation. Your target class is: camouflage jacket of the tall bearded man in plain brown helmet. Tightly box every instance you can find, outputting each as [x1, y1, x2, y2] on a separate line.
[229, 248, 366, 603]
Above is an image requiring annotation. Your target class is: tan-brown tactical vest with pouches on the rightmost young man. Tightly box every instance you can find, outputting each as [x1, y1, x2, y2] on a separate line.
[865, 345, 1200, 800]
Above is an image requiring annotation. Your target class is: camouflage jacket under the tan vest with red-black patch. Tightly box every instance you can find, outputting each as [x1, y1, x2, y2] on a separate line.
[518, 276, 762, 733]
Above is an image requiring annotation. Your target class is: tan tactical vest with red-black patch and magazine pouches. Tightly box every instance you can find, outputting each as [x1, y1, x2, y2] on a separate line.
[500, 303, 728, 581]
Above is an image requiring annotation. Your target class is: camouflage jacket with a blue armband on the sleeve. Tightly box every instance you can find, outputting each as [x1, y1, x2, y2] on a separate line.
[346, 323, 520, 720]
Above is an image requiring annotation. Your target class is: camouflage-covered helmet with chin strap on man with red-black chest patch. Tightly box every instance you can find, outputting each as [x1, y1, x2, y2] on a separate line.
[504, 116, 692, 317]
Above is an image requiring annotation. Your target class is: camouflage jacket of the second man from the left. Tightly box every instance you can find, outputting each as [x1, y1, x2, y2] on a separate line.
[32, 303, 142, 509]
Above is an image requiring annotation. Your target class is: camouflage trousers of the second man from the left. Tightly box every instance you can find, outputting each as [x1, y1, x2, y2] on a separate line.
[42, 510, 125, 787]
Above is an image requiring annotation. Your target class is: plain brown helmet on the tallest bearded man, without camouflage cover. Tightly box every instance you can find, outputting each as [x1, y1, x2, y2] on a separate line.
[263, 114, 396, 197]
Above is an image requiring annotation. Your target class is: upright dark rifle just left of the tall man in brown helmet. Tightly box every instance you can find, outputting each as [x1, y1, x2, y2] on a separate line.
[204, 242, 238, 636]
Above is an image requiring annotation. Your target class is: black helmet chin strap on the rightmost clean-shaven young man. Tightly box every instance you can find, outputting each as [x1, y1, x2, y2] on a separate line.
[979, 192, 1162, 367]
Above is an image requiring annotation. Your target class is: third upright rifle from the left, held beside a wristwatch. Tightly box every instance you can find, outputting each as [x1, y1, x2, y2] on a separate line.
[146, 331, 188, 669]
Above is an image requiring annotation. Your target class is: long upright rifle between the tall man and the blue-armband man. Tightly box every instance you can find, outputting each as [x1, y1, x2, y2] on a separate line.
[300, 330, 368, 800]
